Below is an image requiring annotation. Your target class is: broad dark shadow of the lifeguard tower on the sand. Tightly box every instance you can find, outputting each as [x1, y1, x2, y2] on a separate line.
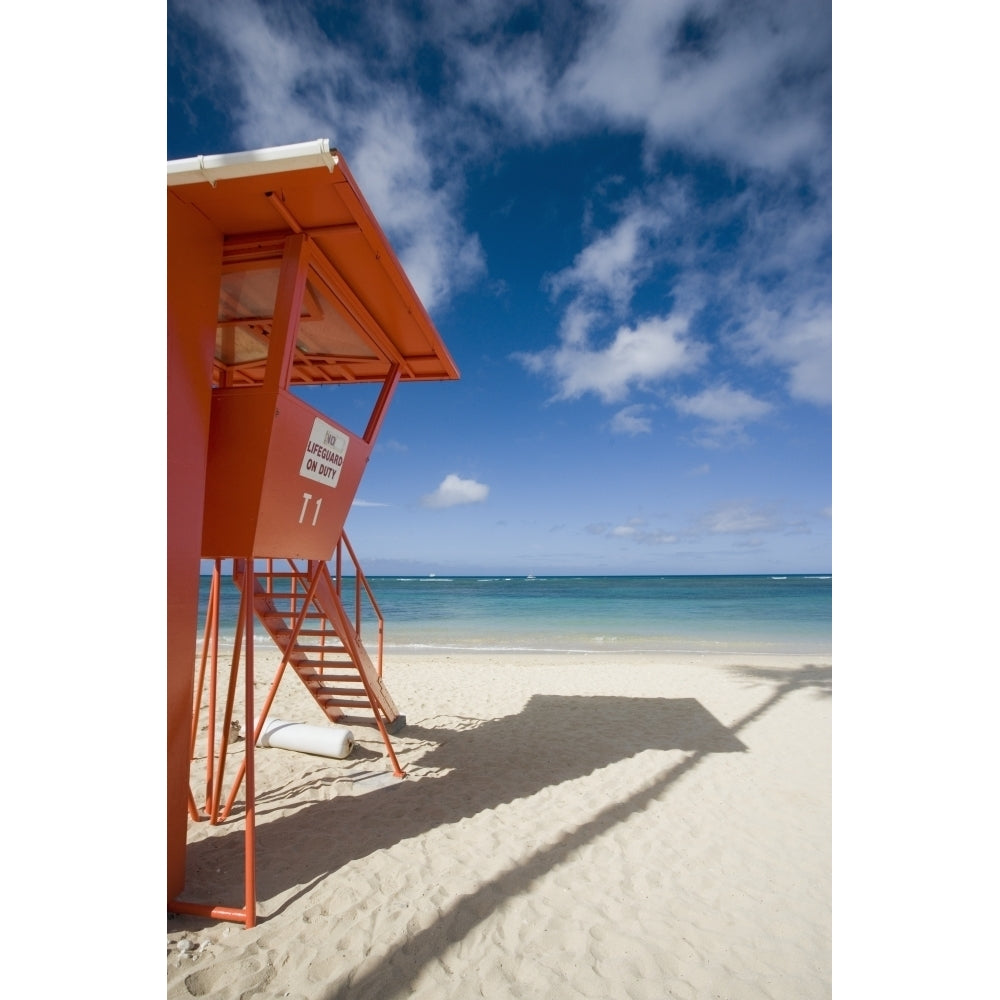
[183, 695, 746, 927]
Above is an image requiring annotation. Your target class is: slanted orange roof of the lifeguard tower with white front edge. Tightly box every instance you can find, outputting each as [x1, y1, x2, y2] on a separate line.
[167, 139, 459, 385]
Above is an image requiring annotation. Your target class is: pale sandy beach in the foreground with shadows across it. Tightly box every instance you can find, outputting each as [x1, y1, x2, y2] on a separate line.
[167, 653, 832, 1000]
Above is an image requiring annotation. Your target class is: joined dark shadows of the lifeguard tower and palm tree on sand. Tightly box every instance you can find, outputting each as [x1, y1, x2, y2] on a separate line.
[172, 665, 831, 1000]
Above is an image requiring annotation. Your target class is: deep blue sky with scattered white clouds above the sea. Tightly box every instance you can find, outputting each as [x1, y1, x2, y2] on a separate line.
[167, 0, 832, 574]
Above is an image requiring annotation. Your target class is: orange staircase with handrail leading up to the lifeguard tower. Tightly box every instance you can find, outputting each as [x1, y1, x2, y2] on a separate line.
[233, 538, 406, 738]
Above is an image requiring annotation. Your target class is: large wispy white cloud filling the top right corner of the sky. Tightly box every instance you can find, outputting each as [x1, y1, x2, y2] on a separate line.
[452, 0, 830, 171]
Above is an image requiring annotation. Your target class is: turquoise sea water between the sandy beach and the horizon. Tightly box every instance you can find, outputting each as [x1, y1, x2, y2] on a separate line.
[202, 575, 833, 654]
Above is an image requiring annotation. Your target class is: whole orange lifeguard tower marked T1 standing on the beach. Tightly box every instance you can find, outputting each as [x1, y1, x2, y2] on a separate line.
[167, 139, 458, 927]
